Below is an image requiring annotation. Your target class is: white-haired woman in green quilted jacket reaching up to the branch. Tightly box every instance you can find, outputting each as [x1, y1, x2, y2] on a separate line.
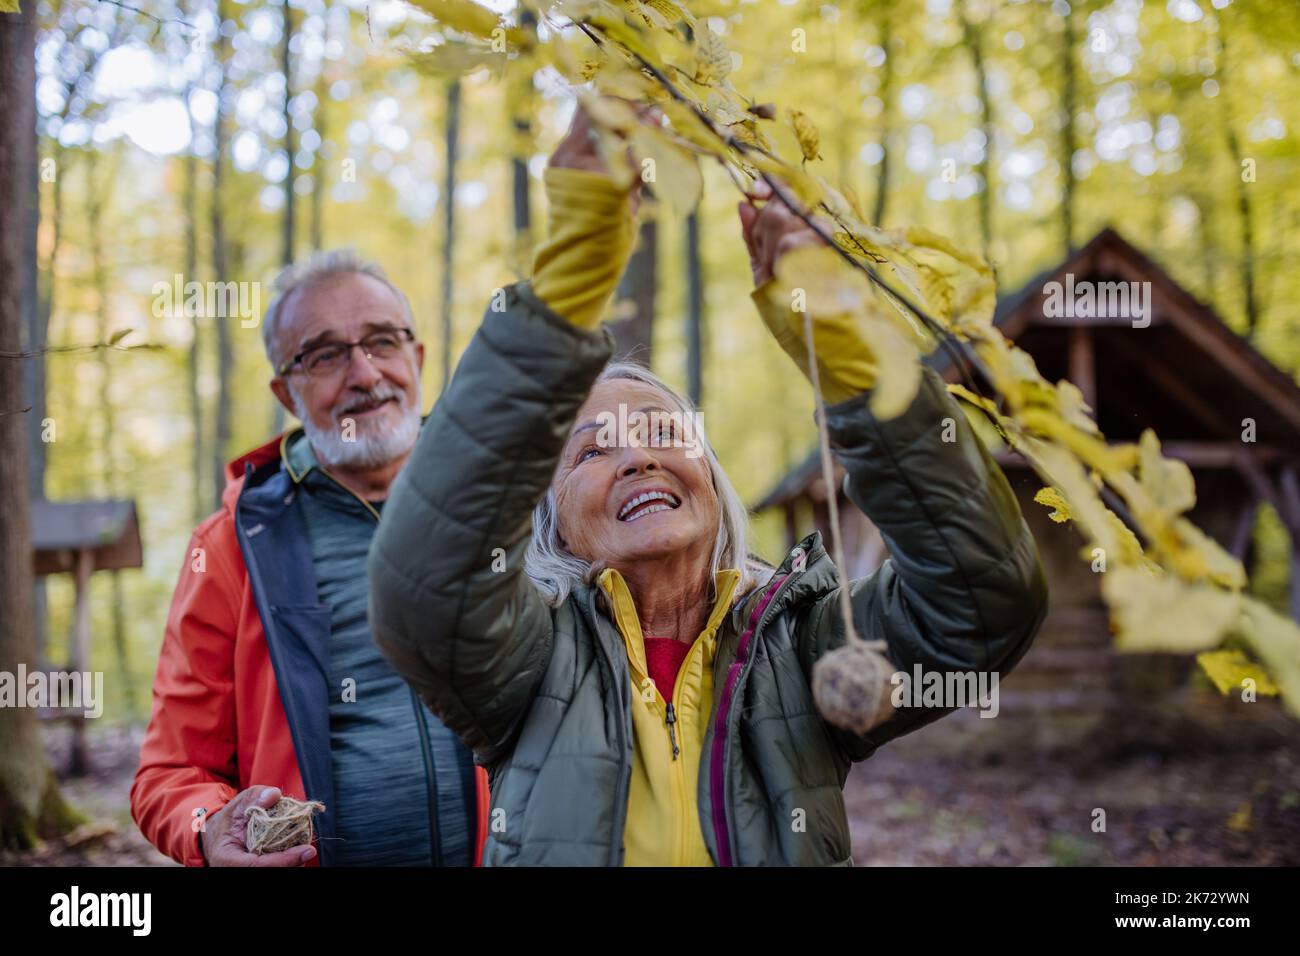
[371, 104, 1047, 866]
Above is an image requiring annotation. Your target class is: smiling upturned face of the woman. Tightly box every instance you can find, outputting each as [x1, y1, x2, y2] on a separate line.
[554, 378, 719, 571]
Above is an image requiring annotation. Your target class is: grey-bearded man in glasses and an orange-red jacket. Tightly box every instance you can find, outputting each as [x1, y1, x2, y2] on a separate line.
[131, 251, 488, 866]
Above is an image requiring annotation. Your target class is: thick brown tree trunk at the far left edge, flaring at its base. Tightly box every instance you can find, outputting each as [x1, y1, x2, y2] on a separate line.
[0, 3, 82, 849]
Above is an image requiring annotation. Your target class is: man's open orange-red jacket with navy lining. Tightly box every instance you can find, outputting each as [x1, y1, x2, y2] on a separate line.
[131, 438, 489, 866]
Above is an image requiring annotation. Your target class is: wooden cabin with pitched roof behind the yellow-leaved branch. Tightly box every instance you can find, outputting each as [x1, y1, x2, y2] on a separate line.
[754, 229, 1300, 747]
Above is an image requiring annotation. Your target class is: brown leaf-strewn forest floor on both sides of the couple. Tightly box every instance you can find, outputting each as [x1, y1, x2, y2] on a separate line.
[0, 726, 1300, 866]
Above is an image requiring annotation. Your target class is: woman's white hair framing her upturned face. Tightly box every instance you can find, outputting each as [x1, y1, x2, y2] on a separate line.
[524, 362, 771, 607]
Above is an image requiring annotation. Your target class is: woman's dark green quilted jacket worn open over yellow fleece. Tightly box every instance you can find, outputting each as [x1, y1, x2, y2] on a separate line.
[369, 282, 1047, 866]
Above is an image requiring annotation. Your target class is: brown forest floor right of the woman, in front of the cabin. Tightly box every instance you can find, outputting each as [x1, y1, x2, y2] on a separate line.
[845, 712, 1300, 866]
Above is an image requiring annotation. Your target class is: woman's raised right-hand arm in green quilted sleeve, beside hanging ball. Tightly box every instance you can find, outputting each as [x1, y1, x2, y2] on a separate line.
[740, 183, 1048, 760]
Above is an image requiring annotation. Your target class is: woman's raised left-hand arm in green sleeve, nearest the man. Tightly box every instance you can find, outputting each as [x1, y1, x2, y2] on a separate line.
[369, 100, 637, 763]
